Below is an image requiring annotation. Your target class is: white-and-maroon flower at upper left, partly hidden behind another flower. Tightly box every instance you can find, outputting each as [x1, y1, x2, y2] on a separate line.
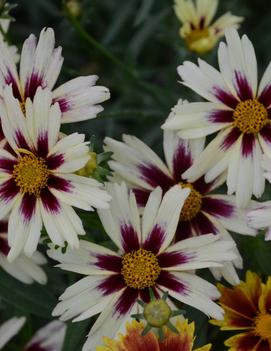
[0, 28, 110, 128]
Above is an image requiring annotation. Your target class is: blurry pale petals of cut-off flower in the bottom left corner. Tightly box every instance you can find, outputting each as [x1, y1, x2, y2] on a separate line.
[0, 317, 66, 351]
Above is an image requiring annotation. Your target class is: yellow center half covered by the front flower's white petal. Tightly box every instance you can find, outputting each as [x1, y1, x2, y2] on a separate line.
[180, 183, 202, 221]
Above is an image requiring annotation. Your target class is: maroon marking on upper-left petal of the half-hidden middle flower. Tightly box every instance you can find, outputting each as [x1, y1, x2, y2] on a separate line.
[138, 164, 174, 191]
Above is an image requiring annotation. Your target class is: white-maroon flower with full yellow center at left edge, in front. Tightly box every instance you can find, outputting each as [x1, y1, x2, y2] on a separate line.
[0, 86, 110, 261]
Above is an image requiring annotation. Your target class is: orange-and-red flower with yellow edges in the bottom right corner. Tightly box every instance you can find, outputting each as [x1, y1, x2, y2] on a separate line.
[212, 271, 271, 351]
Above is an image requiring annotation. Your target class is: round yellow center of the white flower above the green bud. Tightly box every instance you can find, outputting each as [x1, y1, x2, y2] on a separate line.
[121, 249, 161, 289]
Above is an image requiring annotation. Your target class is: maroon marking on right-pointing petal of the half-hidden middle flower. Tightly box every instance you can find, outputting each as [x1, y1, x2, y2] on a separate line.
[201, 196, 234, 218]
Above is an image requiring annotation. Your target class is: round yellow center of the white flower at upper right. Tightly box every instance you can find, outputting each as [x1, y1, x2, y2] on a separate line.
[233, 99, 269, 133]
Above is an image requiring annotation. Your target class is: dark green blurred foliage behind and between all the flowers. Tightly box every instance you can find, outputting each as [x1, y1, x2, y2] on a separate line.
[0, 0, 271, 351]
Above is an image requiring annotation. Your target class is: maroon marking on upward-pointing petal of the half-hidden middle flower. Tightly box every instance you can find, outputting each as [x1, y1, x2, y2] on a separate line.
[173, 141, 193, 183]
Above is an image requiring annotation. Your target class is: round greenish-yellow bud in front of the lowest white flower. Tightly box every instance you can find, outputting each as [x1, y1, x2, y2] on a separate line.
[144, 299, 171, 328]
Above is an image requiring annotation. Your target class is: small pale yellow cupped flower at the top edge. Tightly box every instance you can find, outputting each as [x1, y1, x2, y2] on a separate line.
[174, 0, 243, 54]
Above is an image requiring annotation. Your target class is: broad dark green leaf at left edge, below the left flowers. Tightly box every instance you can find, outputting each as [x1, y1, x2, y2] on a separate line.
[0, 270, 57, 318]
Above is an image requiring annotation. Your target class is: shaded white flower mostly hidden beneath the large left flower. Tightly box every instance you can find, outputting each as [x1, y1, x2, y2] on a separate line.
[0, 219, 47, 284]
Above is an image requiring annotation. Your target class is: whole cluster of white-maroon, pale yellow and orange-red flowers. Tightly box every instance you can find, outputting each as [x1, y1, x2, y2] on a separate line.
[0, 0, 271, 351]
